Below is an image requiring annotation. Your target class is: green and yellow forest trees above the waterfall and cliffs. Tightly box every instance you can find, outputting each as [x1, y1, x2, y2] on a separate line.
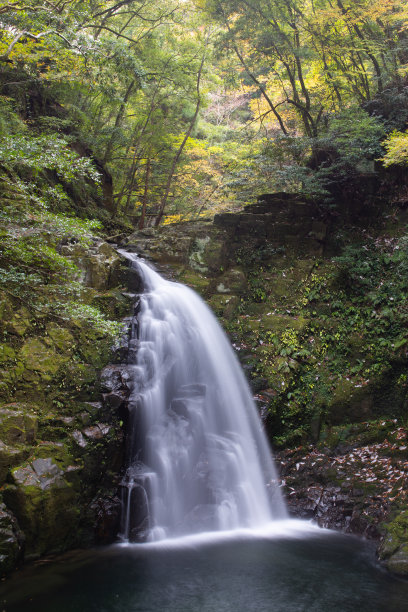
[0, 0, 408, 227]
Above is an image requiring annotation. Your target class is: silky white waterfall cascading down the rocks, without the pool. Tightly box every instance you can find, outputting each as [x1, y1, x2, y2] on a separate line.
[121, 252, 286, 542]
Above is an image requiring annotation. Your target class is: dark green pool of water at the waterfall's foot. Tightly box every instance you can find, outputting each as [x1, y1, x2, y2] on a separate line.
[0, 531, 408, 612]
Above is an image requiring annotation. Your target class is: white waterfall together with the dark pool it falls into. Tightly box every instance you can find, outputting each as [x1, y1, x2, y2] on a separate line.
[0, 254, 408, 612]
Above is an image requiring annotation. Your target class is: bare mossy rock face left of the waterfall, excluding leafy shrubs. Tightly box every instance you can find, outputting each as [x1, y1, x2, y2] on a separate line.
[0, 241, 131, 572]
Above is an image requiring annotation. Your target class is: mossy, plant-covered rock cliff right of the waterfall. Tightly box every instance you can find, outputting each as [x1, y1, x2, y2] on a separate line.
[122, 194, 408, 573]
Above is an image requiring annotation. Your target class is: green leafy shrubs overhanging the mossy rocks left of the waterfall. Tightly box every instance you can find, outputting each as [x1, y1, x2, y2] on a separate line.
[0, 171, 118, 338]
